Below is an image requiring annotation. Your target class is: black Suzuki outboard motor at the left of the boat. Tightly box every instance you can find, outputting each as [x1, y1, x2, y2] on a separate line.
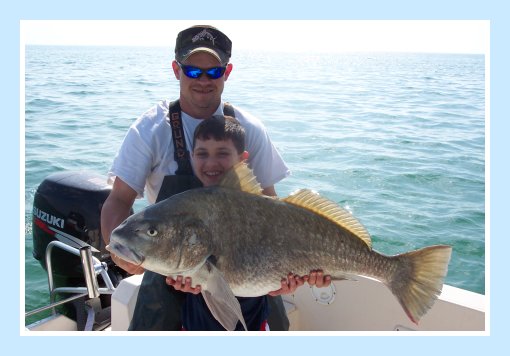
[32, 171, 125, 285]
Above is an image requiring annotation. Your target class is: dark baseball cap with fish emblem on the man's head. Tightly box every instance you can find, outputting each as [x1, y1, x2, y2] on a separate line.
[175, 26, 232, 65]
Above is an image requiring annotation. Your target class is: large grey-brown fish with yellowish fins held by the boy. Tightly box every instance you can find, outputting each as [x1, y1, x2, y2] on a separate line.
[109, 164, 452, 330]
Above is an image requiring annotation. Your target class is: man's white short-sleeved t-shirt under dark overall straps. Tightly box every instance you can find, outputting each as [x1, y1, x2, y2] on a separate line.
[108, 100, 290, 203]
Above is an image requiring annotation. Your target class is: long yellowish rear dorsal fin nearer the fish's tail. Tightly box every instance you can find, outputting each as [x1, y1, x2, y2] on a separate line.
[282, 189, 372, 248]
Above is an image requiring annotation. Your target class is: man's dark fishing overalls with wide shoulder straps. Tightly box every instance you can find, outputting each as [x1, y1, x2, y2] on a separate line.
[129, 100, 289, 331]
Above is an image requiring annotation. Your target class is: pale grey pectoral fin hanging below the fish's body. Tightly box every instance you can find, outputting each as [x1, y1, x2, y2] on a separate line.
[201, 261, 248, 330]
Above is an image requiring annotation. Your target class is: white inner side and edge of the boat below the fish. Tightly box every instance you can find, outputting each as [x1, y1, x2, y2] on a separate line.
[102, 276, 486, 332]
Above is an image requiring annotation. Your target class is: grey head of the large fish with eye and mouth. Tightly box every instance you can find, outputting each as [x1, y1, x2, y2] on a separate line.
[109, 204, 212, 276]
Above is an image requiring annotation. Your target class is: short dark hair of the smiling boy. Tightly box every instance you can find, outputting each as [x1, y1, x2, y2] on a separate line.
[193, 115, 245, 154]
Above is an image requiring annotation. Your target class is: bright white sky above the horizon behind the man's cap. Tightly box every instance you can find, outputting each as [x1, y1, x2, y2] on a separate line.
[21, 20, 490, 53]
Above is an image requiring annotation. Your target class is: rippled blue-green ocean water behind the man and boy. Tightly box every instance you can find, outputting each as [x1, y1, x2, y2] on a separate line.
[24, 46, 488, 318]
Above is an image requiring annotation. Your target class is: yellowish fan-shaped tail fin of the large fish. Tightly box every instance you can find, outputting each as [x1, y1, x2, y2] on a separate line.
[389, 245, 452, 324]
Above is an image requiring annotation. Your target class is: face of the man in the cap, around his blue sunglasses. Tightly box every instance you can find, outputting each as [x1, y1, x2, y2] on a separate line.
[173, 52, 232, 118]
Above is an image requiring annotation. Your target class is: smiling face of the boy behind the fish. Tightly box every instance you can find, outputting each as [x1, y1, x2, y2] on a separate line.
[191, 139, 248, 187]
